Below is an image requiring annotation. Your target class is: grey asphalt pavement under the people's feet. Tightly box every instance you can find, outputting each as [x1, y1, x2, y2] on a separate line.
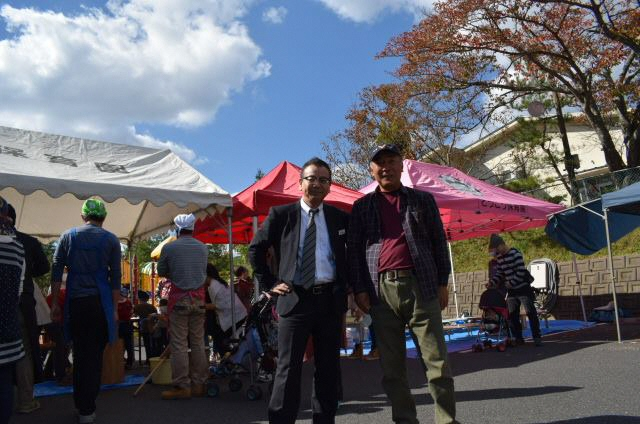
[11, 324, 640, 424]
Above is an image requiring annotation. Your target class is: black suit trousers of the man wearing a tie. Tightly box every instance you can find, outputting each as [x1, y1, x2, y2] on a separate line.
[269, 289, 342, 424]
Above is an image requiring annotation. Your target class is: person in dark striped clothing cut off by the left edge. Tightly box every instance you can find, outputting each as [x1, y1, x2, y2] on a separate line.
[0, 197, 25, 424]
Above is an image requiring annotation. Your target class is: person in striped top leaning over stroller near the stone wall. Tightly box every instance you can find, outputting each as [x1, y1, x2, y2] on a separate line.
[487, 234, 542, 346]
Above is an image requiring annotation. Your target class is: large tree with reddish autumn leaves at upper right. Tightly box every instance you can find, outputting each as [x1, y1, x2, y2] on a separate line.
[380, 0, 640, 171]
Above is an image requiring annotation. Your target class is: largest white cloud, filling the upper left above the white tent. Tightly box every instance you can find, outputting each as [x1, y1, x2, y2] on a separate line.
[0, 0, 270, 161]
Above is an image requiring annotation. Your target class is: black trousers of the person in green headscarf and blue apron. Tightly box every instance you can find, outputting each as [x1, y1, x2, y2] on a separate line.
[69, 296, 109, 415]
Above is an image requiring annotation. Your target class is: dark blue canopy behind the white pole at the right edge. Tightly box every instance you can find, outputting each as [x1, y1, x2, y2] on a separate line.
[545, 200, 640, 255]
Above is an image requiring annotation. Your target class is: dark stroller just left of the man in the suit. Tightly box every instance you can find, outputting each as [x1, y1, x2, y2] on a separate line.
[207, 294, 278, 400]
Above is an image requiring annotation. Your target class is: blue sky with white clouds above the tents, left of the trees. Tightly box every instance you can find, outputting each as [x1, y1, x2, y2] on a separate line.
[0, 0, 428, 193]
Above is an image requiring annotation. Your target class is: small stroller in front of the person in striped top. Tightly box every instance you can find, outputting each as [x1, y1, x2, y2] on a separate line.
[472, 288, 512, 352]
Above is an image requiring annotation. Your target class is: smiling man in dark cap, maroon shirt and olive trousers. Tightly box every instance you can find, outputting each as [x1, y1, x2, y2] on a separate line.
[347, 145, 457, 424]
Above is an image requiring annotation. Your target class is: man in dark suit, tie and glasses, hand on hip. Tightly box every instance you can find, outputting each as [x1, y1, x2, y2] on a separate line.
[249, 158, 348, 424]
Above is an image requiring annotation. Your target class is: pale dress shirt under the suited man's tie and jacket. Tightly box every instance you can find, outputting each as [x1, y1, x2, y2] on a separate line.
[294, 199, 336, 284]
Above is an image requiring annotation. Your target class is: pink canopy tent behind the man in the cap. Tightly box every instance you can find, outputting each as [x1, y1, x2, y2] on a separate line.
[360, 159, 564, 241]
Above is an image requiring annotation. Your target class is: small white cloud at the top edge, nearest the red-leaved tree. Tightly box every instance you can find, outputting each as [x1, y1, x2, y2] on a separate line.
[319, 0, 434, 23]
